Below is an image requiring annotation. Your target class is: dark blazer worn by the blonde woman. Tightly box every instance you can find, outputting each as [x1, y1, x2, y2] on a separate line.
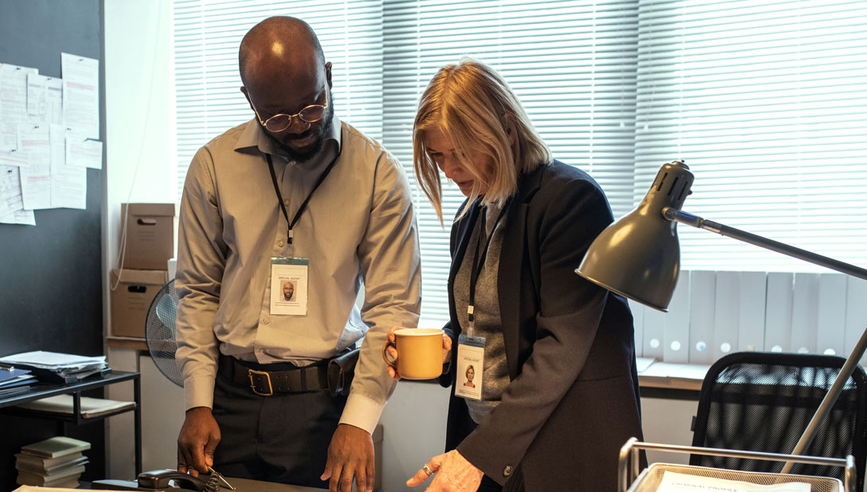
[440, 161, 642, 492]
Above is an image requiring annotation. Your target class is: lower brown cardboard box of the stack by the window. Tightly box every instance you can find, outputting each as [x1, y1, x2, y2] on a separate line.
[111, 269, 169, 338]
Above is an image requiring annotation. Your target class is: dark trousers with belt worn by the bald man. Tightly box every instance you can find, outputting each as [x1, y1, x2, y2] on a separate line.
[214, 368, 346, 487]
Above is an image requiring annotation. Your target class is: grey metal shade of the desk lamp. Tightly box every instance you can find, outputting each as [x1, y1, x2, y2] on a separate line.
[575, 161, 693, 311]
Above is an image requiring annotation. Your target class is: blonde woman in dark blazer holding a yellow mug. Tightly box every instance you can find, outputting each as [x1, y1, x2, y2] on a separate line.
[389, 60, 641, 492]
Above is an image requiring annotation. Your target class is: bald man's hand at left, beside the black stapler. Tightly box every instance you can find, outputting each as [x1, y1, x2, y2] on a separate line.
[178, 407, 220, 477]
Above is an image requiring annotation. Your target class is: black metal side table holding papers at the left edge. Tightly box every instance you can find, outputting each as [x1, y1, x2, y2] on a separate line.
[0, 371, 142, 474]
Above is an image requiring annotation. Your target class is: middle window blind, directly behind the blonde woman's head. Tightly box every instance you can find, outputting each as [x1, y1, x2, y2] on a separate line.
[383, 0, 637, 326]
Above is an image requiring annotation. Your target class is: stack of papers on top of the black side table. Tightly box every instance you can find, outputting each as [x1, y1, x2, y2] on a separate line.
[0, 350, 108, 383]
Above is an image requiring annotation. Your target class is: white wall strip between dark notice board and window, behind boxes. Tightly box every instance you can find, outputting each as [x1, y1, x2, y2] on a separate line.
[103, 0, 176, 479]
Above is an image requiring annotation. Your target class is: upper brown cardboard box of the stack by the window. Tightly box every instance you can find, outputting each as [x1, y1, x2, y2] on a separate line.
[121, 203, 176, 270]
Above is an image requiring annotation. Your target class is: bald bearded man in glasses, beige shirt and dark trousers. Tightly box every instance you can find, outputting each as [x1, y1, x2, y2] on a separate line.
[176, 17, 420, 491]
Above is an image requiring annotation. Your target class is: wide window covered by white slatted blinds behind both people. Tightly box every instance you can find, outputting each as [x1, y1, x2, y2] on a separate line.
[174, 0, 867, 326]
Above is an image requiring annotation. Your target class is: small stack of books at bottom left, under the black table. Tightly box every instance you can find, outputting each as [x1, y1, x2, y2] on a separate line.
[15, 437, 90, 489]
